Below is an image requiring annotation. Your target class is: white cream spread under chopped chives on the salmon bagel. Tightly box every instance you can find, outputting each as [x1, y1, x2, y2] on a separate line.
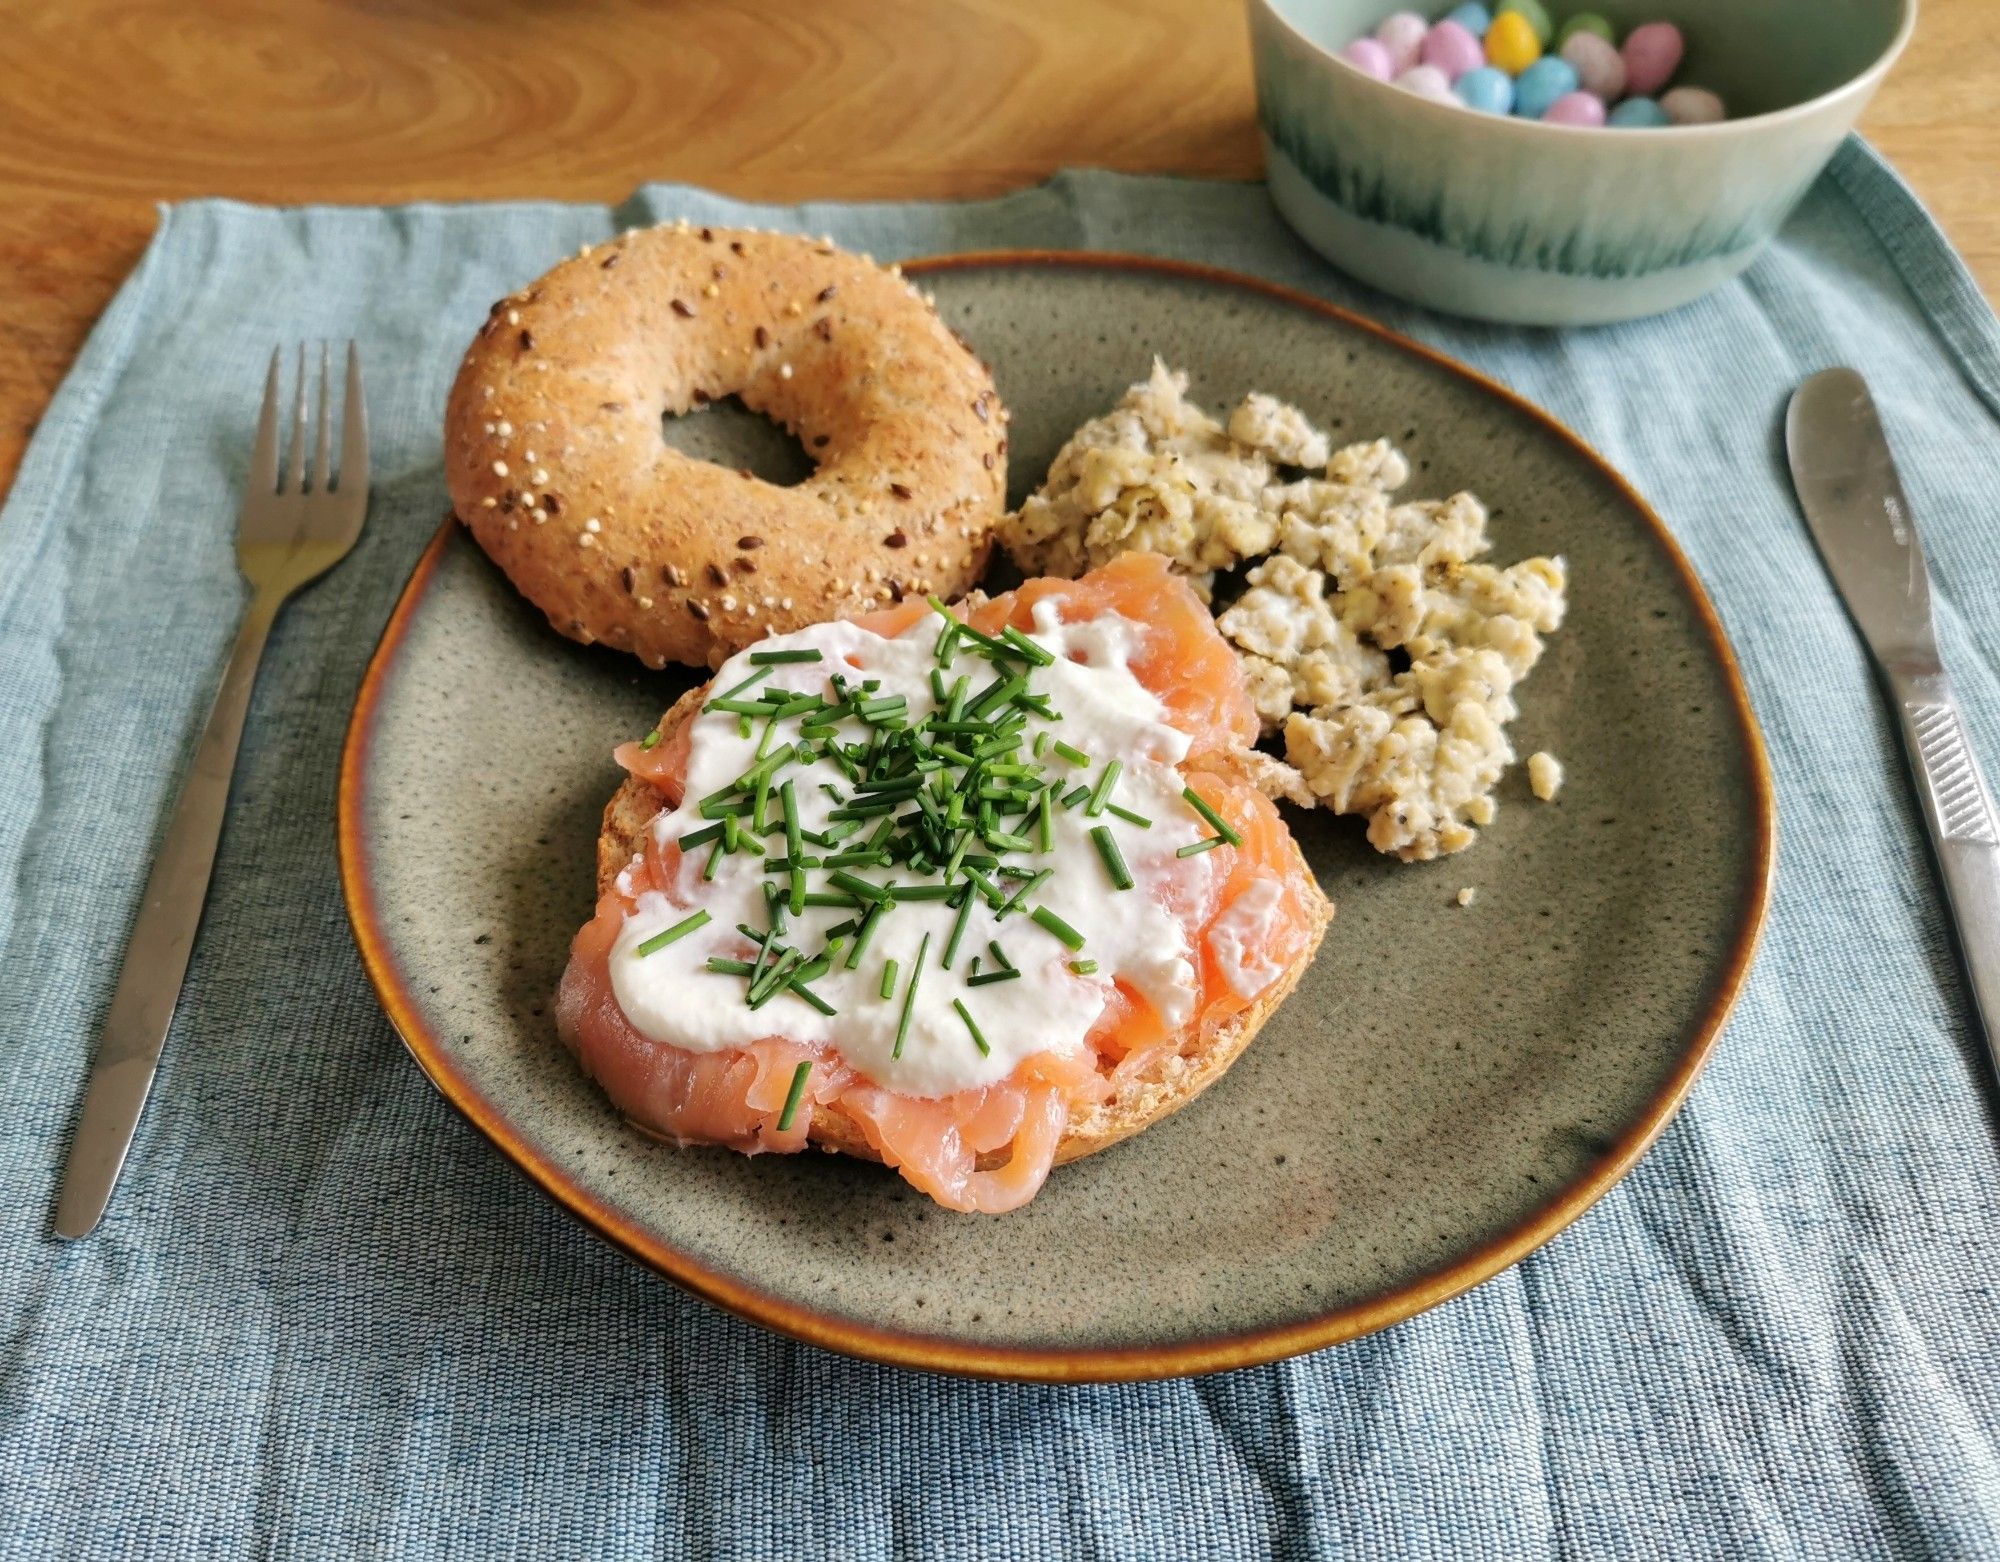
[610, 602, 1248, 1096]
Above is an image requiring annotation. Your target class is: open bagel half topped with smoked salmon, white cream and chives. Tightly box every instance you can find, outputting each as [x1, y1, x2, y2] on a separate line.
[558, 554, 1332, 1212]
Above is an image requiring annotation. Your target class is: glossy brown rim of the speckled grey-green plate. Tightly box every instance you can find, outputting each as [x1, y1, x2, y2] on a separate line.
[338, 250, 1776, 1382]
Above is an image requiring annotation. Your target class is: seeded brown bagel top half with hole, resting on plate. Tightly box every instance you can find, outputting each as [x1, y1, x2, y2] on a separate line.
[444, 224, 1008, 666]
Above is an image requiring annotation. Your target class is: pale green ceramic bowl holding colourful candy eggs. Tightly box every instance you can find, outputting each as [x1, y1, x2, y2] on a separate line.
[1250, 0, 1916, 326]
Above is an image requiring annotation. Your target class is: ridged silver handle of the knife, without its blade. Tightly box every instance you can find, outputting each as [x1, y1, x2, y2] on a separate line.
[1890, 670, 2000, 1076]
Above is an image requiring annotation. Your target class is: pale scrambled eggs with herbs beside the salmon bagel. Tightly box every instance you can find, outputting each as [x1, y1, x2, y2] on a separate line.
[1002, 362, 1566, 862]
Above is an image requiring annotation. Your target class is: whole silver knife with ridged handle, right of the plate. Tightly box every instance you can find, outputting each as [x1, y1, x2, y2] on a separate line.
[1784, 368, 2000, 1072]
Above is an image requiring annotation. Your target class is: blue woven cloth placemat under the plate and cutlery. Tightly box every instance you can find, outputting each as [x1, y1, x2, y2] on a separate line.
[0, 144, 2000, 1560]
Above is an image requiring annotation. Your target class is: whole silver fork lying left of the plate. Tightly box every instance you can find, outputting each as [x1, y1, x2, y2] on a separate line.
[56, 342, 368, 1236]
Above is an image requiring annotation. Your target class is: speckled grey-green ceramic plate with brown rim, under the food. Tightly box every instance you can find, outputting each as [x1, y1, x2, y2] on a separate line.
[340, 256, 1772, 1378]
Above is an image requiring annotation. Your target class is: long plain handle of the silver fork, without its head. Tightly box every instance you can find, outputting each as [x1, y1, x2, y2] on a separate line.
[56, 592, 280, 1238]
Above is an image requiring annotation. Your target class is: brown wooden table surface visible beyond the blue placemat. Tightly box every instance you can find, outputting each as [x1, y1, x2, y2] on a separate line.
[0, 0, 2000, 490]
